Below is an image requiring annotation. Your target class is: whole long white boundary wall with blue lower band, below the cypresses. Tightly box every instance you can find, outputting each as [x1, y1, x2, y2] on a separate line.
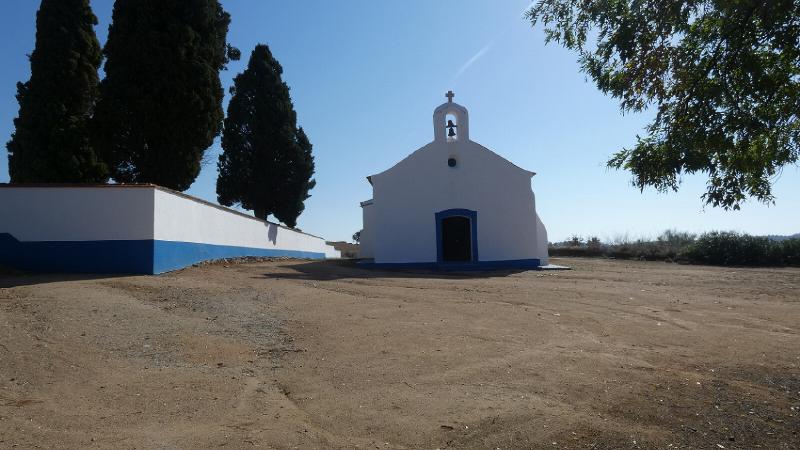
[0, 185, 339, 273]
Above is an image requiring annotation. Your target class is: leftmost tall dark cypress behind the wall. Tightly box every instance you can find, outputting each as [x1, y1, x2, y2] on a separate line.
[6, 0, 108, 183]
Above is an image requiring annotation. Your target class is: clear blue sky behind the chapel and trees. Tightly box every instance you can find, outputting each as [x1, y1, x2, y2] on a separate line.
[0, 0, 800, 241]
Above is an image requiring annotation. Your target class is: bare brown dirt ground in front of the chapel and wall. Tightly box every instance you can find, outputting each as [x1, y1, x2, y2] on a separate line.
[0, 258, 800, 449]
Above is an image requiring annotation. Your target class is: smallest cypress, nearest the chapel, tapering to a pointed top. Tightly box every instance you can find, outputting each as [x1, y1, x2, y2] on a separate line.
[217, 45, 316, 227]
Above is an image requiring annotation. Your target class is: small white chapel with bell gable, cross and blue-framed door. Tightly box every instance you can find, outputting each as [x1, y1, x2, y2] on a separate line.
[360, 92, 548, 268]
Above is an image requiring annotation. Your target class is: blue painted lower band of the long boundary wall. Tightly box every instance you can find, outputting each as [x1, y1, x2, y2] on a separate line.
[0, 233, 325, 275]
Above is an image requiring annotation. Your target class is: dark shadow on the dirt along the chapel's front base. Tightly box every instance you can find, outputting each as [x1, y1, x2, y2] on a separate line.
[262, 259, 535, 281]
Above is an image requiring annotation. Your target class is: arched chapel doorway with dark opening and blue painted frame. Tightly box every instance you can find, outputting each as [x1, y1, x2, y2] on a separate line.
[436, 209, 478, 263]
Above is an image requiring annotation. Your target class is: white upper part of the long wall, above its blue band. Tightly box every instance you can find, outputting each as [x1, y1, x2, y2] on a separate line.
[0, 185, 340, 258]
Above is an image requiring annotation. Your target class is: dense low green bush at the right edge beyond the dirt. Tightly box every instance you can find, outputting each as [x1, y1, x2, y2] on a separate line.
[684, 231, 800, 266]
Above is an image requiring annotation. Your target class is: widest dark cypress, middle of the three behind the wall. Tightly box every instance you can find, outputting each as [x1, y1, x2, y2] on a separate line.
[94, 0, 238, 191]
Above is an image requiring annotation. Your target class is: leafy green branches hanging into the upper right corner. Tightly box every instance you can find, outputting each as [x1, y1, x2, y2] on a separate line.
[527, 0, 800, 209]
